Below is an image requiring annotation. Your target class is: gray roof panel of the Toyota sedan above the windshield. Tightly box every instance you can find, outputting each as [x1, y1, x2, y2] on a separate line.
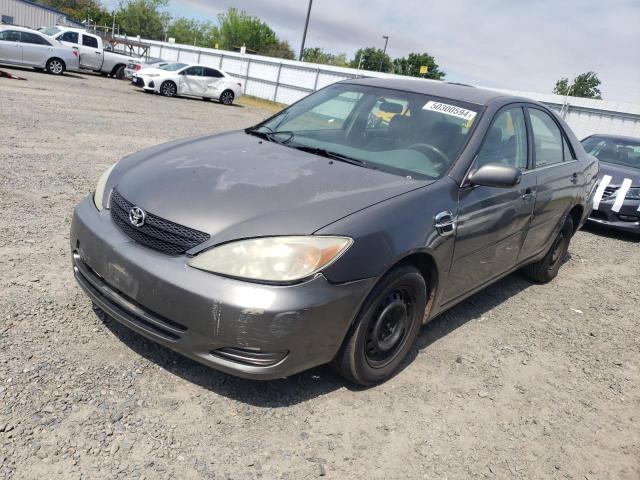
[340, 77, 524, 105]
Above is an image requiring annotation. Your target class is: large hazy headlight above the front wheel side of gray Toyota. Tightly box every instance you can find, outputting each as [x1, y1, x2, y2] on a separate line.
[189, 236, 353, 283]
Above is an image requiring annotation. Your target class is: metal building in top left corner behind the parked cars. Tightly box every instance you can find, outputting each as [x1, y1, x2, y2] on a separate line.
[0, 0, 84, 29]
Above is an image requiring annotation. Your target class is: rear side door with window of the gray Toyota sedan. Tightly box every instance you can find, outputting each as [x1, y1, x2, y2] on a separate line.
[520, 105, 579, 260]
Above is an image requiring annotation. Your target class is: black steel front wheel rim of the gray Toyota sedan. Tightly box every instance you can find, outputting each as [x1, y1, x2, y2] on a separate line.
[364, 288, 415, 368]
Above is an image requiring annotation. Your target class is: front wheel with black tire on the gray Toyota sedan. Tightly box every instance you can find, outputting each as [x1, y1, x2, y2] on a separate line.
[331, 265, 427, 385]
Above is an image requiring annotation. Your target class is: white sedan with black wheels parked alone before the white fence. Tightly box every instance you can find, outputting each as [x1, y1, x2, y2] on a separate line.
[131, 63, 242, 105]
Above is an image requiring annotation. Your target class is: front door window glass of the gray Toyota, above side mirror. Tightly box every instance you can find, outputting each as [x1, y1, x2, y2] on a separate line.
[476, 107, 528, 170]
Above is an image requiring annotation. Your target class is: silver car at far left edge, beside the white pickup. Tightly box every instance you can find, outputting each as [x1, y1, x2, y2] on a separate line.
[0, 25, 79, 75]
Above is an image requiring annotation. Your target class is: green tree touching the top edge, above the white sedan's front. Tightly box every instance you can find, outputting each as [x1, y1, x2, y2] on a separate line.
[116, 0, 169, 41]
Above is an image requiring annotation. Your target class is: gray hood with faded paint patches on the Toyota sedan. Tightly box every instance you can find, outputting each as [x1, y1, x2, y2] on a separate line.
[107, 131, 432, 244]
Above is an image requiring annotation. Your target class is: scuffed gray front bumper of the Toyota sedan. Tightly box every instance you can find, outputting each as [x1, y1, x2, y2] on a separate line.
[71, 196, 373, 380]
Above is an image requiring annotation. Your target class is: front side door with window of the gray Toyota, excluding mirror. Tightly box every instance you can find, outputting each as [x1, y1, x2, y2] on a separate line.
[445, 106, 536, 302]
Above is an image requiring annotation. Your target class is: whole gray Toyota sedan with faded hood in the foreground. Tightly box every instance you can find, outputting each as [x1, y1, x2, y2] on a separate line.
[71, 79, 598, 385]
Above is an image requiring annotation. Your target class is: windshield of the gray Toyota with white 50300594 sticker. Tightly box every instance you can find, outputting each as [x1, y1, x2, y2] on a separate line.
[248, 84, 479, 179]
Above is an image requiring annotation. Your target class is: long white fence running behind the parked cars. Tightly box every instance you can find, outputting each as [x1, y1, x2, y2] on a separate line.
[131, 40, 640, 138]
